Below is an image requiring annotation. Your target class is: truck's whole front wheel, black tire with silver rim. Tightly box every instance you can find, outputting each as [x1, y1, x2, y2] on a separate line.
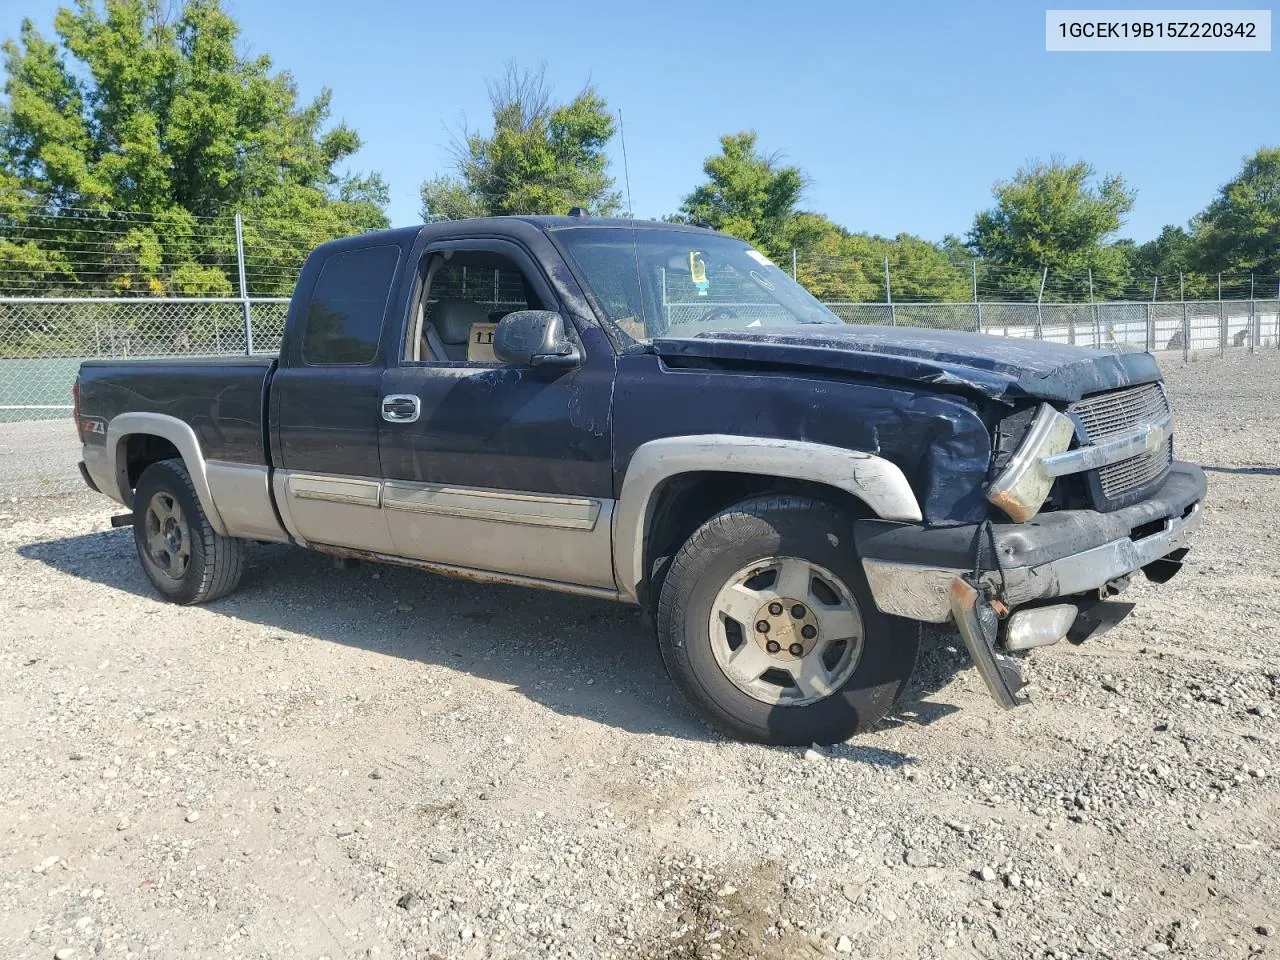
[658, 497, 920, 745]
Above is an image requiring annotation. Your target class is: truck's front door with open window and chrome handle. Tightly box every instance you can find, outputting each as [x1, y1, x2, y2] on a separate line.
[379, 239, 614, 590]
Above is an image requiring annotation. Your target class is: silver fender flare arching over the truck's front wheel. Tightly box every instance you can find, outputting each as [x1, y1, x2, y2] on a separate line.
[613, 434, 922, 600]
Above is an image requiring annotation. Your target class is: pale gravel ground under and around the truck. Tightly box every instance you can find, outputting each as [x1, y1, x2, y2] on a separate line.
[0, 353, 1280, 960]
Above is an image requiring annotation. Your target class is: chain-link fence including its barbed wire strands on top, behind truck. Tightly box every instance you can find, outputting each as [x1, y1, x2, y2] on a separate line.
[0, 212, 1280, 422]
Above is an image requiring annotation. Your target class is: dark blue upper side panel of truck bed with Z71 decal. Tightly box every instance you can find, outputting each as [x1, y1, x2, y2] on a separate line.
[79, 356, 278, 463]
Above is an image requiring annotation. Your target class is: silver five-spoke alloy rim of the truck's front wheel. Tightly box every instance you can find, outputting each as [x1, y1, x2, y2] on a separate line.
[709, 557, 864, 707]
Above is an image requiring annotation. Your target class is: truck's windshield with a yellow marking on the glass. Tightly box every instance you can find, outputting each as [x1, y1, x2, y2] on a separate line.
[556, 227, 841, 340]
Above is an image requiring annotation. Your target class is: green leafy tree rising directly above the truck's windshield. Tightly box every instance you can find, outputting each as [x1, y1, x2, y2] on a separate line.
[675, 131, 803, 262]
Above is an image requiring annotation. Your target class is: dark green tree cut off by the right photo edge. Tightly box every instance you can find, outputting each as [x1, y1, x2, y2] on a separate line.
[1187, 147, 1280, 276]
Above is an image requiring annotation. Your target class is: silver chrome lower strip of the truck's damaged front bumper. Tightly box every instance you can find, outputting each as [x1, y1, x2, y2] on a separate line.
[863, 502, 1204, 623]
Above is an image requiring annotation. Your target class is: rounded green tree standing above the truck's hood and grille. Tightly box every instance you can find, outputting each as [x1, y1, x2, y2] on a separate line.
[968, 157, 1134, 285]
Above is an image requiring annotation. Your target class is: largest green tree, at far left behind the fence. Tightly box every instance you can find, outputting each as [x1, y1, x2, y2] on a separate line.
[0, 0, 387, 294]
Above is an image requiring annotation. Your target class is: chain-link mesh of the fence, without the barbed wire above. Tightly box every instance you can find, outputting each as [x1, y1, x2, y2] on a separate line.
[0, 289, 1280, 422]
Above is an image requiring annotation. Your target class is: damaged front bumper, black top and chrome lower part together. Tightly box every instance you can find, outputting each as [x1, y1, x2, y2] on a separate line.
[854, 462, 1206, 623]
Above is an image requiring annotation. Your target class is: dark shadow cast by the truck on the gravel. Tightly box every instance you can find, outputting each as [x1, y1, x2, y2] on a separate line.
[17, 530, 955, 767]
